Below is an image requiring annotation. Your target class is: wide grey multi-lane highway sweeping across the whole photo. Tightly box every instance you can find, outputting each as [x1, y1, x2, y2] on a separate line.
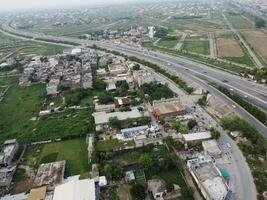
[2, 22, 267, 138]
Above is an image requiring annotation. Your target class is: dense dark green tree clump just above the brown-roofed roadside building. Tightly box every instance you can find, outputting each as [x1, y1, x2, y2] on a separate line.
[139, 83, 174, 103]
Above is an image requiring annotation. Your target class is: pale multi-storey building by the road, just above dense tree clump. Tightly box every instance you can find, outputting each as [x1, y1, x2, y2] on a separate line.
[133, 69, 155, 87]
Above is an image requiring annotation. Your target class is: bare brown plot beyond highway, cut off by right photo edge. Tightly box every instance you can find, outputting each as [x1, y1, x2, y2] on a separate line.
[244, 31, 267, 62]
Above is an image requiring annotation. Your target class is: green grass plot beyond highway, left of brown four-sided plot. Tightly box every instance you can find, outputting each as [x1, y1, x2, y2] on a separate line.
[183, 41, 210, 55]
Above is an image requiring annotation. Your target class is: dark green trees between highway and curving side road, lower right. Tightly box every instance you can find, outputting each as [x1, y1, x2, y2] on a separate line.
[222, 117, 267, 194]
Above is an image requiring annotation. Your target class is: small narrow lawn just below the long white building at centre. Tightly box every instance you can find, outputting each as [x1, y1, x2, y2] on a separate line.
[96, 139, 135, 151]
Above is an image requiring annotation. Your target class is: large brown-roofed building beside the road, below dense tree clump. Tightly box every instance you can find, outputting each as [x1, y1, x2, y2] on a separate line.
[152, 98, 187, 120]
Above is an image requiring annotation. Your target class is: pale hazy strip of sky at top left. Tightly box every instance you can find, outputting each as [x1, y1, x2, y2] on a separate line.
[0, 0, 138, 11]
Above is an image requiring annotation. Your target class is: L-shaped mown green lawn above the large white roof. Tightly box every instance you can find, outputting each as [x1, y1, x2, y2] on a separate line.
[36, 138, 90, 176]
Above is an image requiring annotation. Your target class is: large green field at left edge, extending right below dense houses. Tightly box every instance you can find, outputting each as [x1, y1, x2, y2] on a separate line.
[0, 78, 94, 143]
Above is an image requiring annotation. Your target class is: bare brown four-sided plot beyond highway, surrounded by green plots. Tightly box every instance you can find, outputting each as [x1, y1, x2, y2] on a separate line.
[217, 38, 244, 57]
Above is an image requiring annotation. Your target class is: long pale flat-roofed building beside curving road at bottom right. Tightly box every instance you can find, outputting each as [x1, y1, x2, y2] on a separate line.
[187, 156, 229, 200]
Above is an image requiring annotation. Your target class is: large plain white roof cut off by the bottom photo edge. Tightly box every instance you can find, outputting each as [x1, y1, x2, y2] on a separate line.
[53, 179, 97, 200]
